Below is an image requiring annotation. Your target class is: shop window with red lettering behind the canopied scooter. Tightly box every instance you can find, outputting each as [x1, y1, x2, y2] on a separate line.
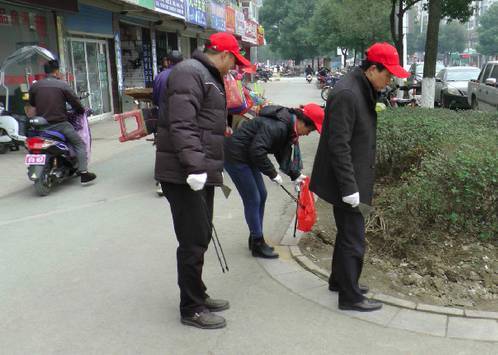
[0, 2, 57, 114]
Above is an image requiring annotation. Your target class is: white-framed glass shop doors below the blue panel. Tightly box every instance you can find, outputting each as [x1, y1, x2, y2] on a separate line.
[68, 38, 112, 115]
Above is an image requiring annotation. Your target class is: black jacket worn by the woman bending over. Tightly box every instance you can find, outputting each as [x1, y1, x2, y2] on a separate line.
[225, 106, 301, 180]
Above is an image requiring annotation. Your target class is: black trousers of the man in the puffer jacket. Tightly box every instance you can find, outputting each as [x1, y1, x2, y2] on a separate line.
[161, 182, 214, 316]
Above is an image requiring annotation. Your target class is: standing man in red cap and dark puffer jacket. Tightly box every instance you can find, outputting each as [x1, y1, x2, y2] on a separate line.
[155, 33, 250, 329]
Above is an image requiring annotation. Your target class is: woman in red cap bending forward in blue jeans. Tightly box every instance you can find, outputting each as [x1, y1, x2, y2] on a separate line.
[224, 104, 324, 258]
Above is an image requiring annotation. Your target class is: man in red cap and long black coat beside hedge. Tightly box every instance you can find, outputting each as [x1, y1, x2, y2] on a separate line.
[310, 43, 409, 312]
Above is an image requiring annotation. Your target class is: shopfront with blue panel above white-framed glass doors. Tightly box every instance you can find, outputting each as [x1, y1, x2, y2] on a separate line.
[64, 5, 115, 119]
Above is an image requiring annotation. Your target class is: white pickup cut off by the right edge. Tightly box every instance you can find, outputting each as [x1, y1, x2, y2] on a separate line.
[467, 61, 498, 112]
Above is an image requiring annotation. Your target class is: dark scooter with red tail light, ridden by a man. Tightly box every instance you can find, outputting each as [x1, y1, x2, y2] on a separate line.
[24, 109, 92, 196]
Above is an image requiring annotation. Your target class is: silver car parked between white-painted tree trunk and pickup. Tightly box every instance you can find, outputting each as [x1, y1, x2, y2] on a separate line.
[434, 67, 481, 109]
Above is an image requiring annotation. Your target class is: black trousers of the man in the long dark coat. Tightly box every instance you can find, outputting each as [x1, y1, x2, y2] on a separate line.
[329, 206, 365, 303]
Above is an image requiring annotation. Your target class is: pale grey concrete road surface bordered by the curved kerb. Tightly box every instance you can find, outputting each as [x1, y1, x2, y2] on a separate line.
[0, 79, 497, 355]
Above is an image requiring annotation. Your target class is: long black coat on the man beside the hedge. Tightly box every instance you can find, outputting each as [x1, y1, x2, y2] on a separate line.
[310, 69, 377, 208]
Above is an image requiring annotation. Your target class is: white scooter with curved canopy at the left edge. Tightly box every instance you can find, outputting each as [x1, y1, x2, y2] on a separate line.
[0, 46, 55, 154]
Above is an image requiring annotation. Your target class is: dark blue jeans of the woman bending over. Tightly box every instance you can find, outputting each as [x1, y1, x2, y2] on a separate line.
[225, 162, 267, 239]
